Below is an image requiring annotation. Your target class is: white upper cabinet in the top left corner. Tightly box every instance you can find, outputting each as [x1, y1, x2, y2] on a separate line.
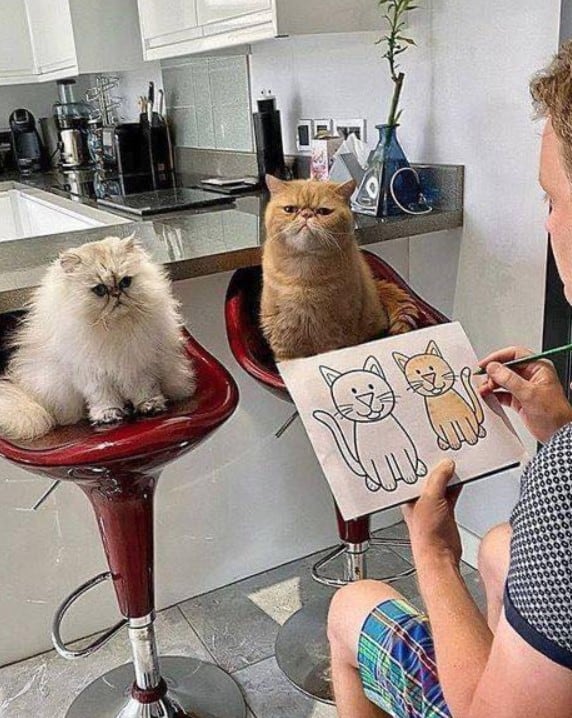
[0, 0, 143, 85]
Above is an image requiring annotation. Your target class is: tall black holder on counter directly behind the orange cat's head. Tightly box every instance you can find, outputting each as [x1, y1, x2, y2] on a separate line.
[253, 93, 289, 182]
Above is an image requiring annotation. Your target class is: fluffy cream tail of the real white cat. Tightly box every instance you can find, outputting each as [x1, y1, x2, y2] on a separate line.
[0, 380, 55, 441]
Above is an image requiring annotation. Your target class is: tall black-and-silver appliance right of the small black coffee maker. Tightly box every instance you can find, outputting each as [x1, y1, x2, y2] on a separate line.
[53, 79, 94, 170]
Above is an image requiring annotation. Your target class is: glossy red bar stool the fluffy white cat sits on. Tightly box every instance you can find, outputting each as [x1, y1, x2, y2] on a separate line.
[0, 315, 246, 718]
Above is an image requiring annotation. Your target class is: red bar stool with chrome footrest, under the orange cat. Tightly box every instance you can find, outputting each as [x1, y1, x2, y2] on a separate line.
[225, 250, 449, 703]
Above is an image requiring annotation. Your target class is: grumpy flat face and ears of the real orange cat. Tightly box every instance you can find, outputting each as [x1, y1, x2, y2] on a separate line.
[265, 175, 355, 252]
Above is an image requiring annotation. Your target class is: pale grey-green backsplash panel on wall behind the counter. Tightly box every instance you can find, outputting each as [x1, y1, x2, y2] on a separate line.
[162, 55, 253, 152]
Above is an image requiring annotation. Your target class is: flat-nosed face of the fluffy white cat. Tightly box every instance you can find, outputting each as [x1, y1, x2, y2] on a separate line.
[59, 237, 150, 325]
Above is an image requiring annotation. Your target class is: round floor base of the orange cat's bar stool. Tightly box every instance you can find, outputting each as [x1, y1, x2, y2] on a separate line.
[274, 596, 334, 704]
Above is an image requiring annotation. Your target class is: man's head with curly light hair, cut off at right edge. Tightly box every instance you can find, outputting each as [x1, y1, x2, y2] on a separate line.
[531, 42, 572, 304]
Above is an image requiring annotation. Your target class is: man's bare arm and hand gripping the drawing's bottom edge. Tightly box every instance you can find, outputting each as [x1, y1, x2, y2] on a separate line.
[404, 461, 572, 718]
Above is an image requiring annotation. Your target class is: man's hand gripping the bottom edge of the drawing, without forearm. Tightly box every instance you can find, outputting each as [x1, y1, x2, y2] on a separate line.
[402, 459, 462, 567]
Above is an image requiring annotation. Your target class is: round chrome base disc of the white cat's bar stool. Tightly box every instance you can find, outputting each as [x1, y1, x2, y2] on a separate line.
[65, 656, 246, 718]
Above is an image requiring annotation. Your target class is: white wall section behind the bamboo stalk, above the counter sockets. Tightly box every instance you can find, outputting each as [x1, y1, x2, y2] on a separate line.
[250, 24, 431, 161]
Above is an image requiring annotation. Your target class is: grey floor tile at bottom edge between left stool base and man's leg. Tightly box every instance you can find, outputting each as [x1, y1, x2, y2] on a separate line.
[233, 658, 337, 718]
